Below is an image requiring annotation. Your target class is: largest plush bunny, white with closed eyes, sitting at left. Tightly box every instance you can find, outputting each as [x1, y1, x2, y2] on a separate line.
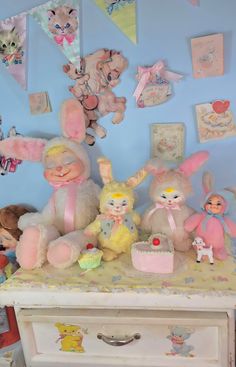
[0, 99, 100, 269]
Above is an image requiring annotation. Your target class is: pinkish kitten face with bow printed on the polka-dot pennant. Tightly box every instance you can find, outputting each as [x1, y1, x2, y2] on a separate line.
[48, 5, 79, 46]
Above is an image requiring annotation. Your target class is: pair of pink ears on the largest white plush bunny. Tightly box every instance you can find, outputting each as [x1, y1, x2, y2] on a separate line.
[0, 99, 85, 162]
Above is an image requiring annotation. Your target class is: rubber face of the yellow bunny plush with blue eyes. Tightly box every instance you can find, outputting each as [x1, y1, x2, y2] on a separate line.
[104, 192, 130, 215]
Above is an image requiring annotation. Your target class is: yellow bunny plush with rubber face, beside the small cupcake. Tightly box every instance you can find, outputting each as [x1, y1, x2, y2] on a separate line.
[85, 158, 147, 261]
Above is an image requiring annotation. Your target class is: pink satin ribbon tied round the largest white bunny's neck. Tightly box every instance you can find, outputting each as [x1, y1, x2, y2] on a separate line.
[50, 178, 85, 233]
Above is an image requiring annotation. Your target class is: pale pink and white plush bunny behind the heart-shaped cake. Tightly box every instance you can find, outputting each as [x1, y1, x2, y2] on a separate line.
[141, 151, 208, 251]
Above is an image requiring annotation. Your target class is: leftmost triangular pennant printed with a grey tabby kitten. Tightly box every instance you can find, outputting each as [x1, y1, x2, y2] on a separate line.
[0, 14, 27, 89]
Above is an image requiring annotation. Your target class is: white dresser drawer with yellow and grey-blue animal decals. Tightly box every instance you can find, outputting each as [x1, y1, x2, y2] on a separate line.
[18, 309, 229, 367]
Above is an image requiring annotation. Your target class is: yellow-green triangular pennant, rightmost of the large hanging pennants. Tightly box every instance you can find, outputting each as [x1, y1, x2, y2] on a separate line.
[95, 0, 137, 44]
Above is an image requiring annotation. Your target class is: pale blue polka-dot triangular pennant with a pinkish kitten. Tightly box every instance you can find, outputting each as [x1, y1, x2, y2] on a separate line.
[29, 0, 80, 68]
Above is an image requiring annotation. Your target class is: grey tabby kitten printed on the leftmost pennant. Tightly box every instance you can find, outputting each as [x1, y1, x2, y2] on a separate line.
[0, 27, 23, 66]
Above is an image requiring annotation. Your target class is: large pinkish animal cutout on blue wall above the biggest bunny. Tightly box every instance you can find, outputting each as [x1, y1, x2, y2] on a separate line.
[63, 49, 128, 145]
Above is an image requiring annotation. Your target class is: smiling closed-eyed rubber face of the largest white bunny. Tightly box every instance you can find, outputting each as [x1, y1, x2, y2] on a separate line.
[44, 146, 84, 184]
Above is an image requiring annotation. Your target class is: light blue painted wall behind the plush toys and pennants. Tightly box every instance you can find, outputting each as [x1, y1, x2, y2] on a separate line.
[0, 0, 236, 213]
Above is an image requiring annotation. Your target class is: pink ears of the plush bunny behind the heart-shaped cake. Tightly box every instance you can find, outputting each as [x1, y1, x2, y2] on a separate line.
[145, 151, 209, 177]
